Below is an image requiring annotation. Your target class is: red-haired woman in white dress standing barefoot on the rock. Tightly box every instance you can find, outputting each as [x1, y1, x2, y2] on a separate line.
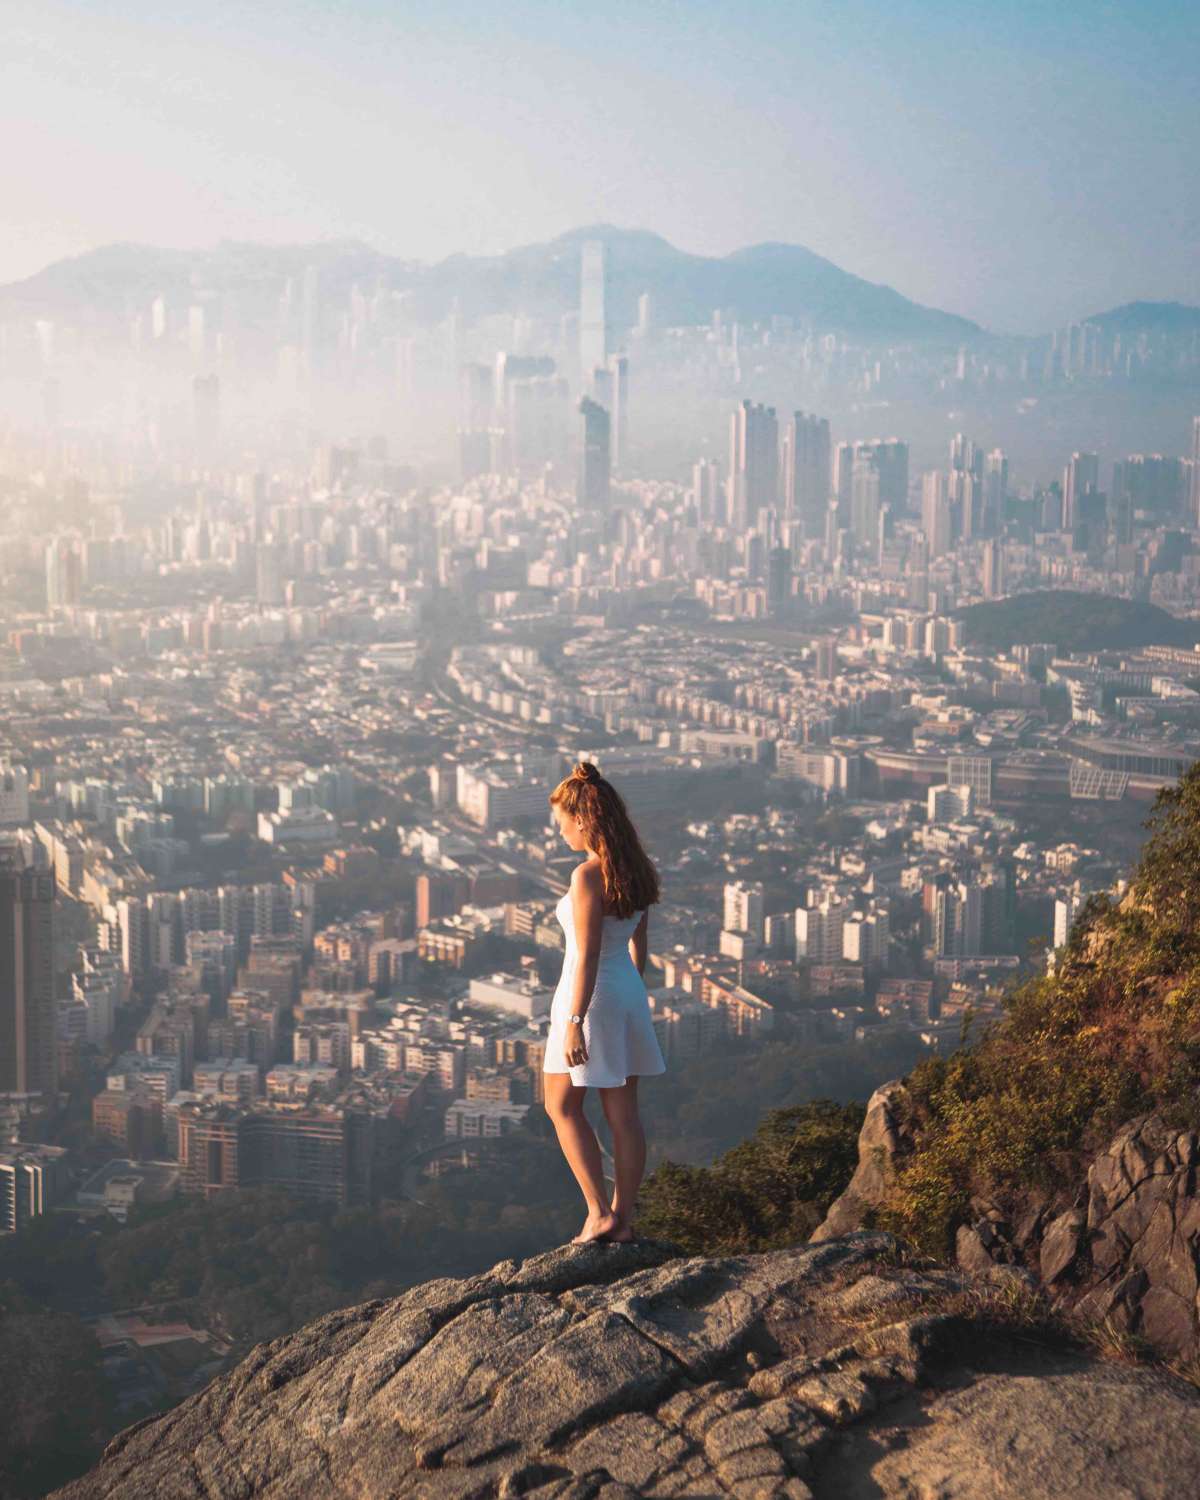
[543, 761, 666, 1245]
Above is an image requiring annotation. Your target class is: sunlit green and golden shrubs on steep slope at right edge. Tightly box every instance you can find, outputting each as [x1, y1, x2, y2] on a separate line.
[881, 765, 1200, 1254]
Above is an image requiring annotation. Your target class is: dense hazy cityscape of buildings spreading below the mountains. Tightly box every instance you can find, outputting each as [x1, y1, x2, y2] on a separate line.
[0, 228, 1200, 1482]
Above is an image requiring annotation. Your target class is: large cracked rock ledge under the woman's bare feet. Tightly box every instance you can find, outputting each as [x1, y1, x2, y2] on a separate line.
[60, 1233, 1200, 1500]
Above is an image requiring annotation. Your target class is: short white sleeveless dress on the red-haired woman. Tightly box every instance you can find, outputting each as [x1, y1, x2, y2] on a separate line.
[542, 891, 666, 1089]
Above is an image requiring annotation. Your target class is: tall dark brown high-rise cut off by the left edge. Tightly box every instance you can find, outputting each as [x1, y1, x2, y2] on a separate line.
[0, 857, 59, 1097]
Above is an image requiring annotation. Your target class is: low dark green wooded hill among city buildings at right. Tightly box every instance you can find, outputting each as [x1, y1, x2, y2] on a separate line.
[957, 588, 1200, 651]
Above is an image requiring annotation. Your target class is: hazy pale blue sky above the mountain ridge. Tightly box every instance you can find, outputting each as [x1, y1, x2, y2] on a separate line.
[9, 0, 1200, 332]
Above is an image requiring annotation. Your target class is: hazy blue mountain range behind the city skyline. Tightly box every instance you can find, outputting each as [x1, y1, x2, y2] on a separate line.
[0, 225, 1200, 344]
